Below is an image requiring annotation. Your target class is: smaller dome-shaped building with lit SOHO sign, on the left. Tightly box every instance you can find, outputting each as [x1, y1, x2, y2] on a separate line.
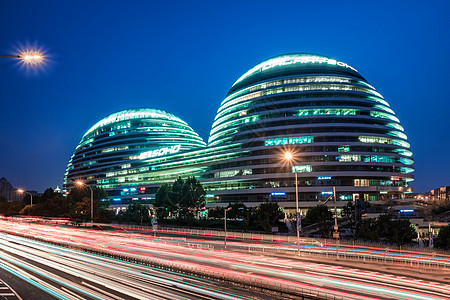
[64, 108, 206, 196]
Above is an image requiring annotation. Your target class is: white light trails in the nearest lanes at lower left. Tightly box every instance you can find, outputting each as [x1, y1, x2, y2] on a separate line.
[0, 231, 260, 299]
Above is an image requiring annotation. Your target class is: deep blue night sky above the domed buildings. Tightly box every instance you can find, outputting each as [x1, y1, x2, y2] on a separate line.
[0, 0, 450, 192]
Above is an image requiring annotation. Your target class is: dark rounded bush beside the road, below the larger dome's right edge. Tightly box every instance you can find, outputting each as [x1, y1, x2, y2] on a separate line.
[358, 214, 417, 245]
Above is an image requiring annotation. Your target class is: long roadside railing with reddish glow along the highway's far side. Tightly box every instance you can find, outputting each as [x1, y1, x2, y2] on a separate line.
[108, 225, 450, 269]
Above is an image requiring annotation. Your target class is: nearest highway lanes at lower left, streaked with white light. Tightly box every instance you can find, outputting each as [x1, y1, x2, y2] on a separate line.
[0, 234, 267, 299]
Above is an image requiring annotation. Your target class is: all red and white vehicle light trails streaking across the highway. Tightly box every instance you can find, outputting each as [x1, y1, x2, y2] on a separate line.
[0, 221, 450, 300]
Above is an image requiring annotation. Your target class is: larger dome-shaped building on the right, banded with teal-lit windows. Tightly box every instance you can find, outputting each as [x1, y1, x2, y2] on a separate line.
[207, 54, 413, 205]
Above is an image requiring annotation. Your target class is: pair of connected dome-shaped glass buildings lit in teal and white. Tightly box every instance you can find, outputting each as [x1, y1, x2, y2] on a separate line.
[65, 54, 413, 209]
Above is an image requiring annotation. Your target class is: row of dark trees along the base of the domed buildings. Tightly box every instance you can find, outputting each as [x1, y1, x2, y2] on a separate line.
[0, 177, 450, 249]
